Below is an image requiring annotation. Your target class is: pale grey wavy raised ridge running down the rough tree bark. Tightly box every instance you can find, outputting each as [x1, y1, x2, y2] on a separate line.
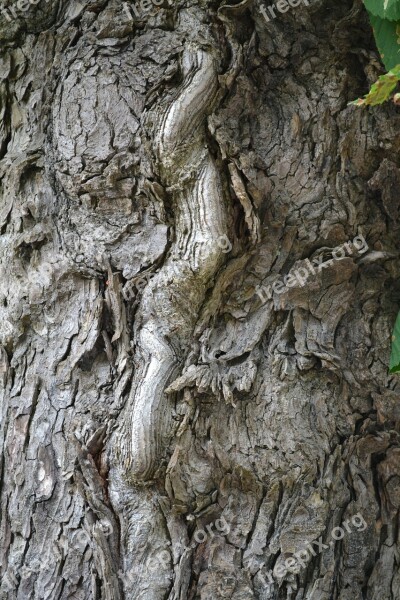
[112, 45, 228, 483]
